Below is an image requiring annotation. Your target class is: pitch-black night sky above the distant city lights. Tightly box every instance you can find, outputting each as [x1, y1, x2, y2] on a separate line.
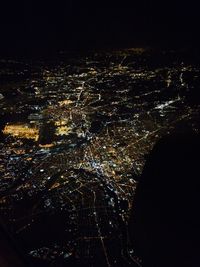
[0, 0, 200, 55]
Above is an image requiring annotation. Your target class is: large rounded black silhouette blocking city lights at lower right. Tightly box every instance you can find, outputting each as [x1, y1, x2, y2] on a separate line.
[129, 133, 200, 267]
